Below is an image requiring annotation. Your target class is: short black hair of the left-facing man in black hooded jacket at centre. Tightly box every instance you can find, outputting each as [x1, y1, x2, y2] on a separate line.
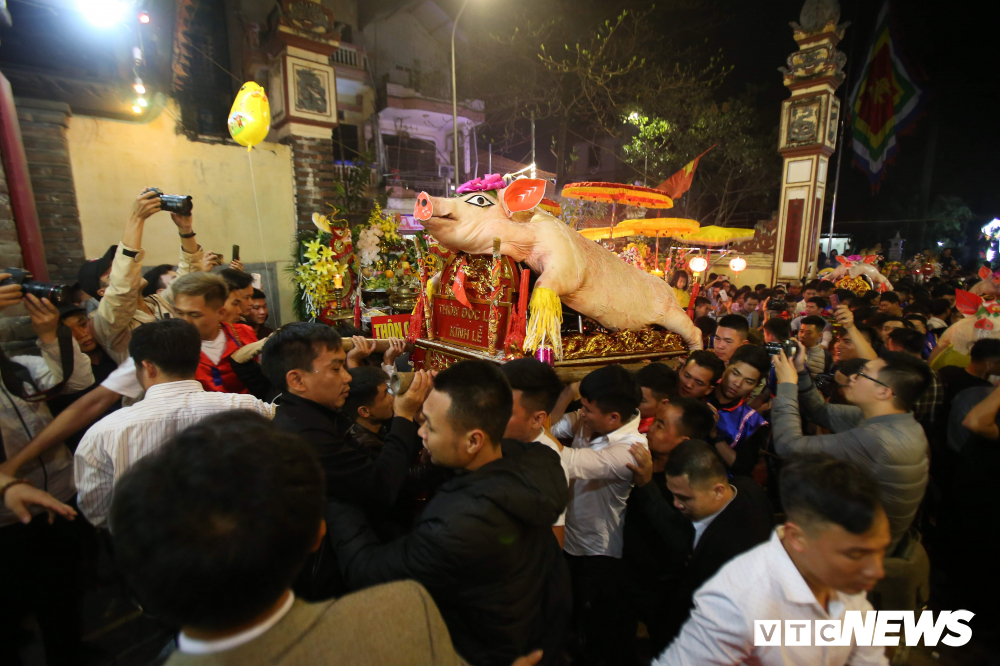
[434, 361, 508, 447]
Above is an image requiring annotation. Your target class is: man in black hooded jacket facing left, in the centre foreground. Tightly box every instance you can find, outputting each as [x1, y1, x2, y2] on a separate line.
[327, 361, 572, 666]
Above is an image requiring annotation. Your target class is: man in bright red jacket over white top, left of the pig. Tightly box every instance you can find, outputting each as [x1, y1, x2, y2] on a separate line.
[173, 273, 257, 393]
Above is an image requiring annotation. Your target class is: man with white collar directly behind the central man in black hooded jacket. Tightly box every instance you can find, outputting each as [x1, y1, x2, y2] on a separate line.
[500, 358, 569, 547]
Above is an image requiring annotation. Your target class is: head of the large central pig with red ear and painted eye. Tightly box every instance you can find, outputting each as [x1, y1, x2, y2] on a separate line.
[413, 177, 545, 254]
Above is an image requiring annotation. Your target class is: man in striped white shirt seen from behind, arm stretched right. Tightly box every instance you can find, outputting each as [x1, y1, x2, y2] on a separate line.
[74, 319, 273, 527]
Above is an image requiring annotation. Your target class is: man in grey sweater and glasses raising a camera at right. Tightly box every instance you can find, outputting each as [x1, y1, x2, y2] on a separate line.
[771, 347, 930, 555]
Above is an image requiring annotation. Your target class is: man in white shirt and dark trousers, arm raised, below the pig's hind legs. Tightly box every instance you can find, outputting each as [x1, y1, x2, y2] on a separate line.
[552, 365, 648, 664]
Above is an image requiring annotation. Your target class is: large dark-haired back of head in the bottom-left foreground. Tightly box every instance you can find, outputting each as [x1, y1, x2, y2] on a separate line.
[110, 412, 326, 631]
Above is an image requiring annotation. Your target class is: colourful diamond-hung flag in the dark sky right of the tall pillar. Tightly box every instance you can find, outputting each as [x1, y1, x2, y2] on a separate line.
[851, 0, 923, 191]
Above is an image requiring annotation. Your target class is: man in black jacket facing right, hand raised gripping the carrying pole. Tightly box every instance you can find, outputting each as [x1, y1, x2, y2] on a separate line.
[262, 323, 431, 601]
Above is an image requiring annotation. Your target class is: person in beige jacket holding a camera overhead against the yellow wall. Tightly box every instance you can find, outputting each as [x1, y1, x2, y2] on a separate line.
[79, 189, 202, 363]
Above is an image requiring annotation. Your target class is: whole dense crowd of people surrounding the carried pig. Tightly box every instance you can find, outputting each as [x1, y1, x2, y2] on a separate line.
[0, 193, 1000, 666]
